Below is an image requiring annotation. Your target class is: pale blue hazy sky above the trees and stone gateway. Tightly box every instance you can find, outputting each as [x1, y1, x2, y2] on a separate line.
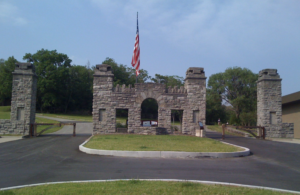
[0, 0, 300, 95]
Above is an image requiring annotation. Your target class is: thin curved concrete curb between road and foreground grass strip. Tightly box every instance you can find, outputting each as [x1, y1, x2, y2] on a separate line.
[0, 179, 300, 194]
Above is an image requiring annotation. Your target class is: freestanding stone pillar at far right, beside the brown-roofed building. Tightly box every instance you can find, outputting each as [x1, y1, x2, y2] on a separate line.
[257, 69, 282, 138]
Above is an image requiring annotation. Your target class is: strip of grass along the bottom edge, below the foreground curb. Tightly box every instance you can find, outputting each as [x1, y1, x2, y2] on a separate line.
[0, 180, 288, 195]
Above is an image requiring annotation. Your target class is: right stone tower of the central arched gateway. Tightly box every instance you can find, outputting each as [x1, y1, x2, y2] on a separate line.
[182, 67, 206, 134]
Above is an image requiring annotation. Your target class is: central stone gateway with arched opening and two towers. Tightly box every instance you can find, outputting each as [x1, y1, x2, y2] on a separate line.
[93, 64, 206, 135]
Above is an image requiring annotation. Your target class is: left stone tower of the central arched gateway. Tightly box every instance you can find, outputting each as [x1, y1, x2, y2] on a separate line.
[93, 64, 116, 134]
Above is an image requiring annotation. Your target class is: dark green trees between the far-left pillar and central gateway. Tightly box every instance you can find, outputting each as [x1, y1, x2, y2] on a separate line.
[23, 49, 93, 113]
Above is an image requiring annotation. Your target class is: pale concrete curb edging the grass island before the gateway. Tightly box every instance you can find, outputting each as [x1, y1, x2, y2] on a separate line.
[79, 136, 250, 159]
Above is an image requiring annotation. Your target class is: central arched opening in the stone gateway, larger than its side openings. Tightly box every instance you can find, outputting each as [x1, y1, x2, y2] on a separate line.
[141, 98, 158, 126]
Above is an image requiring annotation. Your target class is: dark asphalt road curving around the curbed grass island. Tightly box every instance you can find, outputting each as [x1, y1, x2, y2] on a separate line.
[0, 129, 300, 191]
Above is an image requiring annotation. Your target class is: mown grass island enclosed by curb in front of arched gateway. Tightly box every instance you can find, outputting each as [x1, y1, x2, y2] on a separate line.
[85, 134, 242, 152]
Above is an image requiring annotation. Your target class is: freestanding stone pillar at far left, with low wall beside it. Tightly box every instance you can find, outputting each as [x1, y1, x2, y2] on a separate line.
[11, 63, 37, 135]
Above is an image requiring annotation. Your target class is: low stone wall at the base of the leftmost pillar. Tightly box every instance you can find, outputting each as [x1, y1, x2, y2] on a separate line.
[0, 119, 30, 135]
